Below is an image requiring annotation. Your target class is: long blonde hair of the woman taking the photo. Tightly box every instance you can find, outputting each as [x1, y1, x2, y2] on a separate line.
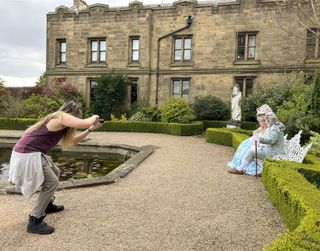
[26, 101, 82, 148]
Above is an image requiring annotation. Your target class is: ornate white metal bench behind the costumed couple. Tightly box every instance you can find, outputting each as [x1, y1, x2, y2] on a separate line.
[273, 131, 312, 163]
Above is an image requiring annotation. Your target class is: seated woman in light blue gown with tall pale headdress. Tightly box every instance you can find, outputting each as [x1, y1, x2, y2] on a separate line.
[227, 104, 272, 175]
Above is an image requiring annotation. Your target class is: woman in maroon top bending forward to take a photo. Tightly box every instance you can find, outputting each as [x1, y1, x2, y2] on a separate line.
[9, 101, 102, 234]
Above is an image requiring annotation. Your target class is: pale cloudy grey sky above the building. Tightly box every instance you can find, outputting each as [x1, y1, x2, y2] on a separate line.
[0, 0, 222, 87]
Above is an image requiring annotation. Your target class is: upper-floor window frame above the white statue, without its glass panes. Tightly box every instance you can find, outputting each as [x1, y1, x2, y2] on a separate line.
[236, 31, 259, 61]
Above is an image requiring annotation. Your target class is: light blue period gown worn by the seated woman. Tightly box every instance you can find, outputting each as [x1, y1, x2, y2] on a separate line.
[227, 137, 263, 175]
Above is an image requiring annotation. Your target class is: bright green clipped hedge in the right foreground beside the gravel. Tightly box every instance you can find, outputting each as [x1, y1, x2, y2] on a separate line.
[262, 160, 320, 251]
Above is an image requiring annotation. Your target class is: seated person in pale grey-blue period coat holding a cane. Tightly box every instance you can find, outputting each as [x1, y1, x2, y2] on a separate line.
[228, 112, 284, 174]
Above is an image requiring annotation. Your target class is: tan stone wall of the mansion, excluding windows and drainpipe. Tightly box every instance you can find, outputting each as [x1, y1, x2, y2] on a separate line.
[46, 0, 317, 103]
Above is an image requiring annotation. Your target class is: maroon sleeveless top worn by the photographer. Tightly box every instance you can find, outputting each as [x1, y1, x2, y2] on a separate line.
[13, 125, 67, 154]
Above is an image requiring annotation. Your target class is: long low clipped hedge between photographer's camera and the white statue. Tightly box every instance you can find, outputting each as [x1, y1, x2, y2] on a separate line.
[97, 121, 203, 136]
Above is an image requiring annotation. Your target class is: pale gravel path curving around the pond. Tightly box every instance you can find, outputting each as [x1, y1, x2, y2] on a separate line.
[0, 130, 285, 251]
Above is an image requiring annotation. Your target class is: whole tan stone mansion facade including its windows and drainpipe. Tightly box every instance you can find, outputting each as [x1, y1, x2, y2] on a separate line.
[46, 0, 320, 105]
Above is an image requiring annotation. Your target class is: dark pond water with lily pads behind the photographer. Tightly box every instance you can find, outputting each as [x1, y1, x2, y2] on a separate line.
[0, 148, 126, 182]
